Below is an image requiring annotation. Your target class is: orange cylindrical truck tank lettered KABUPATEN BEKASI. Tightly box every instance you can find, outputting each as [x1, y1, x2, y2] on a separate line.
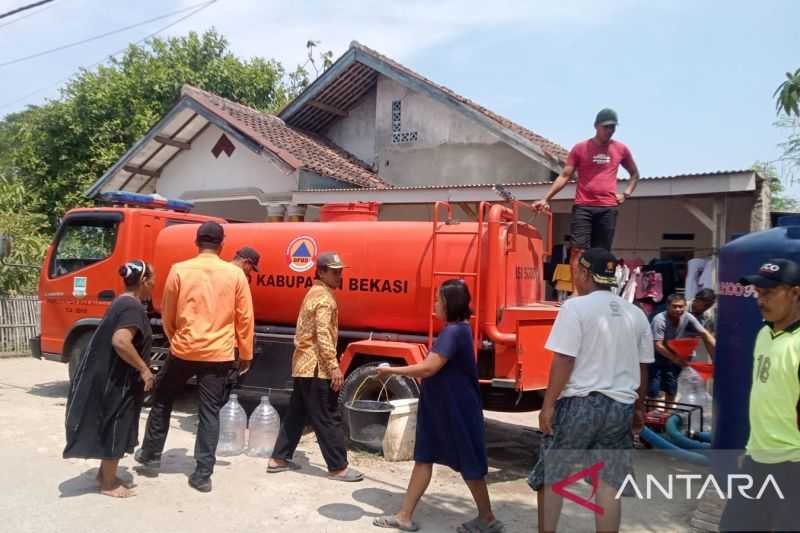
[153, 221, 543, 334]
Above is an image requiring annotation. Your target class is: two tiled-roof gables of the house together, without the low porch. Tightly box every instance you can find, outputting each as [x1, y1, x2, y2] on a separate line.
[87, 38, 567, 220]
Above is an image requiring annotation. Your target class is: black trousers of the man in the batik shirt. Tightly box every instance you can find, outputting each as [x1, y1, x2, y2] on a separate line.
[272, 378, 347, 472]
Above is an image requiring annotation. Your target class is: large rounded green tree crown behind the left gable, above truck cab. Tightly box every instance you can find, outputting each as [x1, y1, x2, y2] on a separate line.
[2, 30, 292, 229]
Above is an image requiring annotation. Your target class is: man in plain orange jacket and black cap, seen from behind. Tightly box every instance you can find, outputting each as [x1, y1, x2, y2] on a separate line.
[134, 222, 254, 492]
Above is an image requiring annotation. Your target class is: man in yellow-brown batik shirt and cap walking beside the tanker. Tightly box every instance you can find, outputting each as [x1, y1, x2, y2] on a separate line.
[267, 252, 364, 481]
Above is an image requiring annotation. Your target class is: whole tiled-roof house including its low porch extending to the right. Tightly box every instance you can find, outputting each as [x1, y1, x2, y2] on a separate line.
[88, 42, 769, 276]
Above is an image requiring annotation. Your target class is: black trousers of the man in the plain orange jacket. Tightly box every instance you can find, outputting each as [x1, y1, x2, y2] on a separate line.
[142, 354, 235, 476]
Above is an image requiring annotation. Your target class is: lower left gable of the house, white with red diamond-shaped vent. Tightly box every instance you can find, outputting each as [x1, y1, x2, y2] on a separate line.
[87, 85, 389, 221]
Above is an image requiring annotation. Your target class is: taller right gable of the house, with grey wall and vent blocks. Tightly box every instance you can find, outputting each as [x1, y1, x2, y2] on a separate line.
[279, 41, 567, 187]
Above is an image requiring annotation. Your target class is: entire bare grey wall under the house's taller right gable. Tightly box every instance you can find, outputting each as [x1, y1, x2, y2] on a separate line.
[326, 76, 549, 185]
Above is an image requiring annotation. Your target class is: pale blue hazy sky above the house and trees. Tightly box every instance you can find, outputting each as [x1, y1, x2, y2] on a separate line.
[0, 0, 800, 198]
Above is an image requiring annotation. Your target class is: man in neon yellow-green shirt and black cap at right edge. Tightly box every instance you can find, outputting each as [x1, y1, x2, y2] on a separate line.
[720, 259, 800, 531]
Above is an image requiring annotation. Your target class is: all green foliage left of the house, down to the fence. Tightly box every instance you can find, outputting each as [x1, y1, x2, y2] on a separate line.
[0, 30, 318, 294]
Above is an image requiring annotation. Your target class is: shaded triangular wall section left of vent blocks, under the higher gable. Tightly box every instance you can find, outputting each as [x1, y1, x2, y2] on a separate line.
[322, 87, 377, 165]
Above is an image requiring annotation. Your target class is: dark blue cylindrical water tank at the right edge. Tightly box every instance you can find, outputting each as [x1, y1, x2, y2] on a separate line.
[714, 217, 800, 450]
